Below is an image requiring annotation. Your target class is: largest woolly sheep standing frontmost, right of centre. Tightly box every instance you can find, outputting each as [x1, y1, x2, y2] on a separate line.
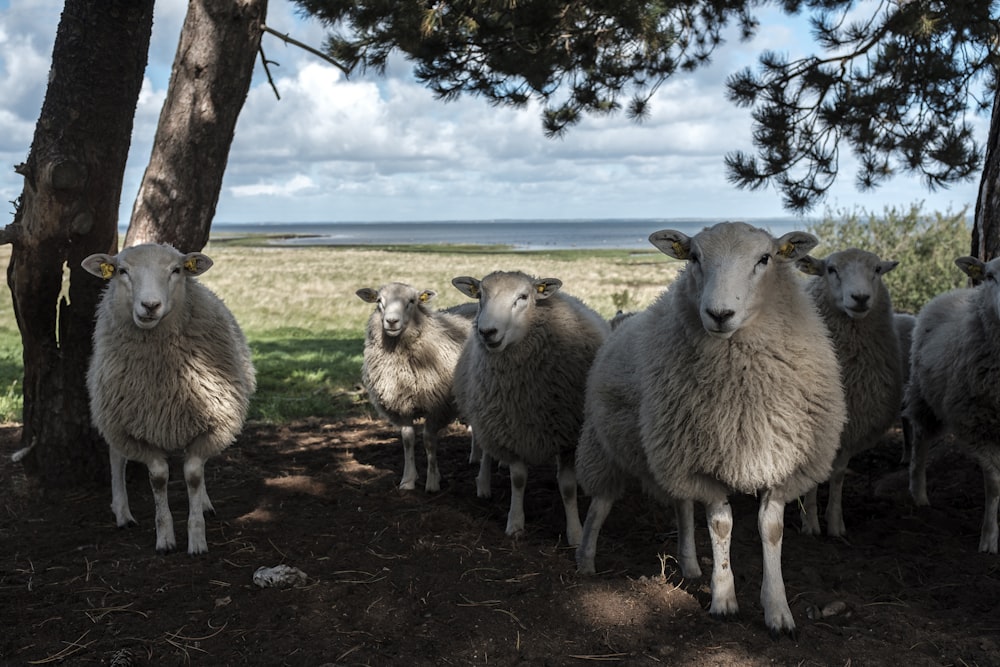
[581, 222, 846, 635]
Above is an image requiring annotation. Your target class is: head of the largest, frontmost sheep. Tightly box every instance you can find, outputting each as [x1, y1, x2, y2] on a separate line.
[649, 222, 819, 339]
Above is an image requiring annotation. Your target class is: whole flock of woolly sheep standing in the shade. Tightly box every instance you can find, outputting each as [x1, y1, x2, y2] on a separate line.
[83, 222, 1000, 637]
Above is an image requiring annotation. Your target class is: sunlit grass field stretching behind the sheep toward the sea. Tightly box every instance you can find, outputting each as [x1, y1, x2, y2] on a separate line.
[0, 237, 680, 423]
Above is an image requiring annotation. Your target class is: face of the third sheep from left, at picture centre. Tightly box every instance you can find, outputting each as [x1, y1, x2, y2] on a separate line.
[451, 271, 562, 352]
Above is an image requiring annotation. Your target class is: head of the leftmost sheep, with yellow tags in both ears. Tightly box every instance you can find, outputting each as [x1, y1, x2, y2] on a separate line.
[82, 243, 212, 329]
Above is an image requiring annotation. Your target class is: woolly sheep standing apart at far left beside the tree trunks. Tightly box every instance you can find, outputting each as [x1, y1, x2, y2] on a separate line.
[82, 244, 257, 554]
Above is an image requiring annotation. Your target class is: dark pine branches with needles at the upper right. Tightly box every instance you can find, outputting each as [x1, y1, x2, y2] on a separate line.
[726, 0, 1000, 212]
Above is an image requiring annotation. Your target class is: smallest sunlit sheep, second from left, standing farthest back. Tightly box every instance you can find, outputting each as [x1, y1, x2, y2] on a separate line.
[356, 282, 472, 493]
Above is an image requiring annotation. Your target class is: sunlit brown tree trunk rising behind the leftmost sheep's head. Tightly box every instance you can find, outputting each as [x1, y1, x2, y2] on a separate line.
[125, 0, 267, 252]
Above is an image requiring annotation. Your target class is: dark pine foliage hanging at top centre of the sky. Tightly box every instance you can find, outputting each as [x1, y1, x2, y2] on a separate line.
[295, 0, 757, 136]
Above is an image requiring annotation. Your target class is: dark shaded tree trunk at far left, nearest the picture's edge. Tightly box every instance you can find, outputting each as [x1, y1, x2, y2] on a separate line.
[2, 0, 153, 487]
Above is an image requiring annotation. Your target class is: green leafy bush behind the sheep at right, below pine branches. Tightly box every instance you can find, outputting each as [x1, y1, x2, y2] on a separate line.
[808, 204, 972, 313]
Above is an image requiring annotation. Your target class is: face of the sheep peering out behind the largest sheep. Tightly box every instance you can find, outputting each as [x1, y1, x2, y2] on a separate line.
[796, 248, 899, 320]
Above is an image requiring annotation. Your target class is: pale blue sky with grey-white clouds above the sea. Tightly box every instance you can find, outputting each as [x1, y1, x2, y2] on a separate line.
[0, 0, 988, 223]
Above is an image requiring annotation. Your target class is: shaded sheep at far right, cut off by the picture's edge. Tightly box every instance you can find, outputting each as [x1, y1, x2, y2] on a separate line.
[906, 257, 1000, 553]
